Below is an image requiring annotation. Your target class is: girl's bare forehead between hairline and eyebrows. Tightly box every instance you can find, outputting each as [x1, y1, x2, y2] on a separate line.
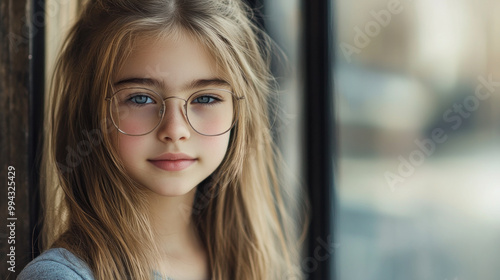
[113, 33, 224, 90]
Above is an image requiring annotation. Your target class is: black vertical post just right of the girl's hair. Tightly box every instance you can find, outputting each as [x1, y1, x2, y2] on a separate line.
[302, 0, 335, 280]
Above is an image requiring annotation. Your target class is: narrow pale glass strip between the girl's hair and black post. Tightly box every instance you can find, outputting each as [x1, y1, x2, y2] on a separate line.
[263, 0, 303, 199]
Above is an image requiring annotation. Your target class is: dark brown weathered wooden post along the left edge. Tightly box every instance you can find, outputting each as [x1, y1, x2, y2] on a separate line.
[0, 0, 44, 279]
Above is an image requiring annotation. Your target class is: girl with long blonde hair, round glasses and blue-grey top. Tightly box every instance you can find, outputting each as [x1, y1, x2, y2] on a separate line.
[19, 0, 300, 280]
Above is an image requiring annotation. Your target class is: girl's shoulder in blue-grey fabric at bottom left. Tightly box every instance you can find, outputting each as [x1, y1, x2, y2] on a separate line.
[17, 248, 94, 280]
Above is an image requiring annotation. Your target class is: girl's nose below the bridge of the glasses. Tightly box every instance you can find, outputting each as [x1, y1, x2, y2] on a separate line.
[157, 97, 191, 142]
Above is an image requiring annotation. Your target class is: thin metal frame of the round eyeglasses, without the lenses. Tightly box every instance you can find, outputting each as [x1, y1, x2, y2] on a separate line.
[104, 87, 245, 137]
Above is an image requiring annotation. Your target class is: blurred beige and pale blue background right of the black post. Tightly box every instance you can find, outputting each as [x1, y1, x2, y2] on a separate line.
[332, 0, 500, 280]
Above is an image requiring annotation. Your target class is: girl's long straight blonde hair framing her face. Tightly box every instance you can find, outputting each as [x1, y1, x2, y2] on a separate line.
[43, 0, 306, 280]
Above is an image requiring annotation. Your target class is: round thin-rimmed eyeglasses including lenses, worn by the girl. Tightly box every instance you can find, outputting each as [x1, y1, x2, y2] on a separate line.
[106, 87, 244, 136]
